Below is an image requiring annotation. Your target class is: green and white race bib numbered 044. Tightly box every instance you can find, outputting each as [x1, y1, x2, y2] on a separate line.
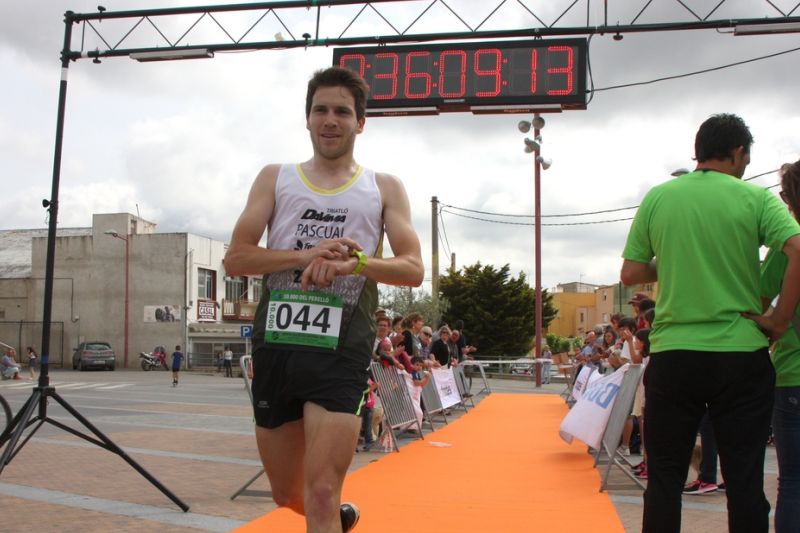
[264, 290, 342, 350]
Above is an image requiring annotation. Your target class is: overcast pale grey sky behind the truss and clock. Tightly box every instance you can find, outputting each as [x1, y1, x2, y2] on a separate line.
[0, 0, 800, 288]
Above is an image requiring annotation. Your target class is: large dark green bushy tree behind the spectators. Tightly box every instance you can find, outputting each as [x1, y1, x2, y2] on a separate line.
[439, 262, 557, 357]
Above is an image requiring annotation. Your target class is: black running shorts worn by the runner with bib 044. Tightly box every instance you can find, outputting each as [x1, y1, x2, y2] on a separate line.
[251, 348, 369, 429]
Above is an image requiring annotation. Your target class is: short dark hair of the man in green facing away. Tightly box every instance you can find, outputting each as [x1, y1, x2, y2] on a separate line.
[694, 113, 753, 163]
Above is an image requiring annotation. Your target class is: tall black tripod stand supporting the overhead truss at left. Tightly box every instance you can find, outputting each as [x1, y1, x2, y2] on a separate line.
[0, 11, 189, 512]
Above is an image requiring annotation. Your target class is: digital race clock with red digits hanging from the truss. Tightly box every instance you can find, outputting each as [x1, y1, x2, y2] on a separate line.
[333, 39, 587, 115]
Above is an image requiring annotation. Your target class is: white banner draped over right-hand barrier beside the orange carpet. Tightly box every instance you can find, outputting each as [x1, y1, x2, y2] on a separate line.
[558, 365, 629, 450]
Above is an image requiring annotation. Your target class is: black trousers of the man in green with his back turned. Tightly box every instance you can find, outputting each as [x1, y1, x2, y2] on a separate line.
[642, 348, 775, 533]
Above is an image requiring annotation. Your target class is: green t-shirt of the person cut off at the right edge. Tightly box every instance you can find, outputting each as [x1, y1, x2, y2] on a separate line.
[761, 250, 800, 387]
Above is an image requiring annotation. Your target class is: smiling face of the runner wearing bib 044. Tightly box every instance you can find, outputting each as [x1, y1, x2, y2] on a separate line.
[306, 87, 364, 160]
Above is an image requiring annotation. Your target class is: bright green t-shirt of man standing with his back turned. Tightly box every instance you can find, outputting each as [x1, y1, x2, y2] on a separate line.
[622, 171, 800, 353]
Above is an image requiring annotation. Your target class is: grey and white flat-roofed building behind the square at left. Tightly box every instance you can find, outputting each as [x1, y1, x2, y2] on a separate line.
[0, 213, 261, 368]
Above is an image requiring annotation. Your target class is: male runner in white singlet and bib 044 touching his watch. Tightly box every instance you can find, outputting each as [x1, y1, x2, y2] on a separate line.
[225, 67, 423, 533]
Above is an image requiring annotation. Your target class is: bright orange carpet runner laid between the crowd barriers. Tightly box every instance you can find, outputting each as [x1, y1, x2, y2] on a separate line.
[236, 393, 624, 533]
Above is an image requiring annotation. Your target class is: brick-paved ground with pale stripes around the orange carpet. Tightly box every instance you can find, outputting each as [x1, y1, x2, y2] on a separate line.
[0, 371, 777, 533]
